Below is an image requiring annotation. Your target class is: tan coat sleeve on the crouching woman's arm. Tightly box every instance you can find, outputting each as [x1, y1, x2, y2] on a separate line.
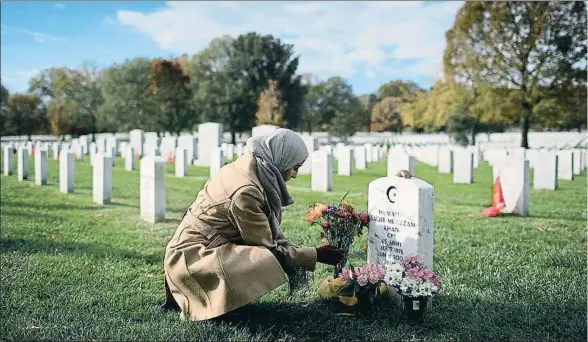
[229, 186, 316, 271]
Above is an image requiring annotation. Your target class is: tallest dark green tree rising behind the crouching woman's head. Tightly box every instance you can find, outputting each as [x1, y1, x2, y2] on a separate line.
[200, 33, 303, 142]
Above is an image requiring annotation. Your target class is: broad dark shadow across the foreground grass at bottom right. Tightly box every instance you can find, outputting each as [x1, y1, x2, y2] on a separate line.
[209, 295, 587, 341]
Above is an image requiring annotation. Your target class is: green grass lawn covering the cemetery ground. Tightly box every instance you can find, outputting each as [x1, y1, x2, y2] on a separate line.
[0, 154, 587, 341]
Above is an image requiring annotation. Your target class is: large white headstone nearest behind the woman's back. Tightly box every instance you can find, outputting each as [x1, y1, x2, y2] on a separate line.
[140, 156, 165, 223]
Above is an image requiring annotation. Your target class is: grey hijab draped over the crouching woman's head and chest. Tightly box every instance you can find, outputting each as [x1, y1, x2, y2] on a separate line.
[247, 128, 308, 242]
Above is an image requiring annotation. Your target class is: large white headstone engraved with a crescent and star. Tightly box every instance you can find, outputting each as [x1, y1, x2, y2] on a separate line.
[368, 176, 435, 270]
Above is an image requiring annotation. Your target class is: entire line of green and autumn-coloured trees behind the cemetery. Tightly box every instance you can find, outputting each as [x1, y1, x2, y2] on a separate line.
[0, 2, 587, 147]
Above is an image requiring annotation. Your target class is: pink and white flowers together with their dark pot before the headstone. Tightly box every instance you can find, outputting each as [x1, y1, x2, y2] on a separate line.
[385, 254, 441, 320]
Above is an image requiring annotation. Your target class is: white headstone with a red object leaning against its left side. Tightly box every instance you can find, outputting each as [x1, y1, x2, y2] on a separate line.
[496, 156, 530, 216]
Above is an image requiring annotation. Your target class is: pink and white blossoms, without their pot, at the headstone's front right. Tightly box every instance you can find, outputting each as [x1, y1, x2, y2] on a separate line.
[386, 254, 441, 297]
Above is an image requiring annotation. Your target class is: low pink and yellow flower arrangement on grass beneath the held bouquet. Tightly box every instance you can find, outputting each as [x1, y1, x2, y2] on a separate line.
[318, 264, 388, 306]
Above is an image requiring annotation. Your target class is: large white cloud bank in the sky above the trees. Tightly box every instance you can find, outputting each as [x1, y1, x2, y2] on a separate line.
[117, 1, 462, 87]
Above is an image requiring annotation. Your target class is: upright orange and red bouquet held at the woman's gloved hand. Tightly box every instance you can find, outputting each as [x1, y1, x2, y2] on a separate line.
[306, 194, 369, 277]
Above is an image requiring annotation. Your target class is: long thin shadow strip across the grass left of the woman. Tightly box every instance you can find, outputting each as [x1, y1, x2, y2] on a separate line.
[0, 238, 163, 264]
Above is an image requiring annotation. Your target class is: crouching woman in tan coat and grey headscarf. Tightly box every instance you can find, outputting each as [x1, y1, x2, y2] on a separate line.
[164, 129, 342, 321]
